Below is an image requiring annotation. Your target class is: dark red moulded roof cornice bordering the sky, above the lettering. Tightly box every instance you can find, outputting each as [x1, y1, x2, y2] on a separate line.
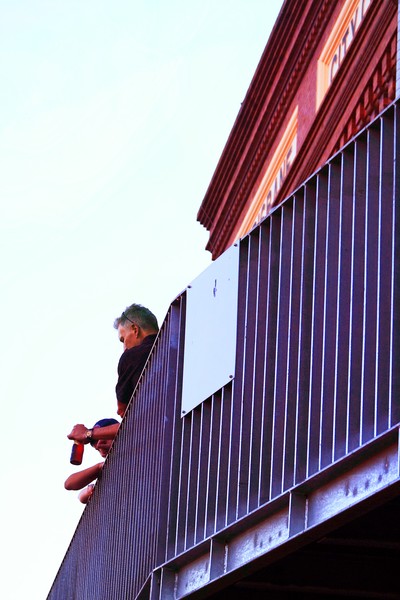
[198, 0, 335, 258]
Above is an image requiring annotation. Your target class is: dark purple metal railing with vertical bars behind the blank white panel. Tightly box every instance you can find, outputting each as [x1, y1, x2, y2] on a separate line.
[48, 103, 400, 600]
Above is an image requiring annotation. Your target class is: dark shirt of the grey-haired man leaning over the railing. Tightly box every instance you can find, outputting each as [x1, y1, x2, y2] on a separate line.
[115, 334, 157, 404]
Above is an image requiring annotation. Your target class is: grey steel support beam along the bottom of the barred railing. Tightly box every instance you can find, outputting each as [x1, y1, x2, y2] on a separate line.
[151, 430, 400, 600]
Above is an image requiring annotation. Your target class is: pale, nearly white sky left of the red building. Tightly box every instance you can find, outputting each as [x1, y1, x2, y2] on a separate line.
[0, 0, 282, 600]
